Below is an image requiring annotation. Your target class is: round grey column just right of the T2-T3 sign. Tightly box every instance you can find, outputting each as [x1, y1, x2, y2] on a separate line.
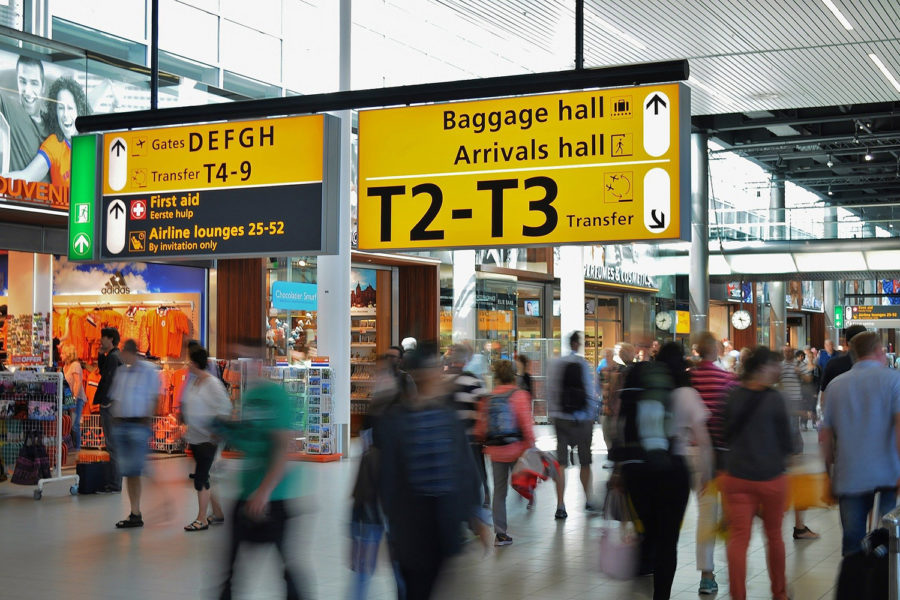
[688, 133, 709, 333]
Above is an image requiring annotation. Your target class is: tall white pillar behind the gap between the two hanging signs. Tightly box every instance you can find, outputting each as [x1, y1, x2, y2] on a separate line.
[317, 0, 352, 458]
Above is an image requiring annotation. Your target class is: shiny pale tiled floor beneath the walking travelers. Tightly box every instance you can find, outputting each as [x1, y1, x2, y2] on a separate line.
[0, 428, 840, 600]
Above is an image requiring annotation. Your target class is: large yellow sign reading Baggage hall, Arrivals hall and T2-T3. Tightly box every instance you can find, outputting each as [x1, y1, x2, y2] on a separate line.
[358, 84, 690, 250]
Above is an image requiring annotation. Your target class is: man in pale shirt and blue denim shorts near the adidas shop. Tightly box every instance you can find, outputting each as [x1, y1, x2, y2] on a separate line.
[109, 340, 159, 529]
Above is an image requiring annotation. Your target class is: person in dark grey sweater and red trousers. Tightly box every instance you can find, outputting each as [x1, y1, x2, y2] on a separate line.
[721, 346, 794, 600]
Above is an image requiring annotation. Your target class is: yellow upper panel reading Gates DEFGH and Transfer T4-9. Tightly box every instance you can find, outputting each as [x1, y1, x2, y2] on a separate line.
[103, 115, 324, 196]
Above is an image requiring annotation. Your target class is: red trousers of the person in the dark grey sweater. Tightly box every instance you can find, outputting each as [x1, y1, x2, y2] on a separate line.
[721, 475, 788, 600]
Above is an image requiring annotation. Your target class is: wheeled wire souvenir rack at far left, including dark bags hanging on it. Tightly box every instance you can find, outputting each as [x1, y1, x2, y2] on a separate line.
[0, 370, 78, 500]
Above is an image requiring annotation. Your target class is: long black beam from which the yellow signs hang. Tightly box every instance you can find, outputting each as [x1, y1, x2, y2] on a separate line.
[75, 60, 690, 133]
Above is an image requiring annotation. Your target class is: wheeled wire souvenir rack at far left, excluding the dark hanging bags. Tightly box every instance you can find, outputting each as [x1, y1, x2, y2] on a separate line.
[0, 371, 78, 500]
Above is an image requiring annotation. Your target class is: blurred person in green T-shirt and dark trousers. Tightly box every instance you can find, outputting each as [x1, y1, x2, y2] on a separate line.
[220, 340, 304, 600]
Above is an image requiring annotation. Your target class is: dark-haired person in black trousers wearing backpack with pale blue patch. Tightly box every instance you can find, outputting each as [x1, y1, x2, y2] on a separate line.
[611, 342, 712, 600]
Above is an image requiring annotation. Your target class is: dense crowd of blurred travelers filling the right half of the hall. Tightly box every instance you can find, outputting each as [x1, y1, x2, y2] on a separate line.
[351, 328, 900, 600]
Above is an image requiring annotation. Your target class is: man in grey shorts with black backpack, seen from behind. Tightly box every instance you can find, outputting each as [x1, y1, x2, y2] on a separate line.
[547, 331, 597, 519]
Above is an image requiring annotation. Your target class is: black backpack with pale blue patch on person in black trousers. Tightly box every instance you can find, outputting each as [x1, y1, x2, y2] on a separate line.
[609, 362, 675, 464]
